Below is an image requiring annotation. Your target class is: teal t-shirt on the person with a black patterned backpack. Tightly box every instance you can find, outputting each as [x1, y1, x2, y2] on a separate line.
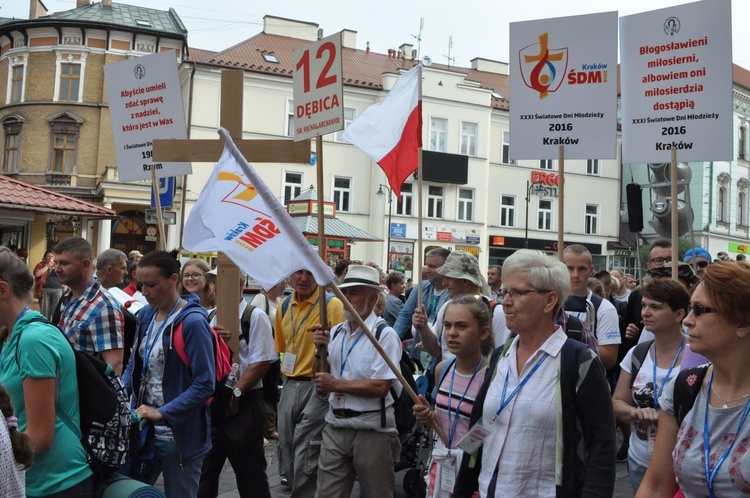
[0, 311, 92, 496]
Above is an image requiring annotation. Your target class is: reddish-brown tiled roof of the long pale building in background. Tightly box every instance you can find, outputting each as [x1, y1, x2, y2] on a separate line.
[191, 33, 510, 109]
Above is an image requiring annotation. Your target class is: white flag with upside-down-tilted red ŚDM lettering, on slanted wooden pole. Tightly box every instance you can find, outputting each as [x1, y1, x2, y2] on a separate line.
[183, 128, 334, 289]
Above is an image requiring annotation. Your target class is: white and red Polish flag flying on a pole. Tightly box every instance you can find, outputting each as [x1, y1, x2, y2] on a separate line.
[341, 64, 422, 198]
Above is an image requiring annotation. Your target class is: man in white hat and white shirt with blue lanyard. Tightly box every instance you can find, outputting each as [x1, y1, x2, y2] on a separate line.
[313, 265, 401, 498]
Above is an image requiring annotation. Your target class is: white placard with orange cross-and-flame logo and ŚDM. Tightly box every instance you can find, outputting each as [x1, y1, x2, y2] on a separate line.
[510, 12, 617, 159]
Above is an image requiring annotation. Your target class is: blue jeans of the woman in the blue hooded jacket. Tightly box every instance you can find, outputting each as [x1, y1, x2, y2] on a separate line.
[143, 441, 203, 498]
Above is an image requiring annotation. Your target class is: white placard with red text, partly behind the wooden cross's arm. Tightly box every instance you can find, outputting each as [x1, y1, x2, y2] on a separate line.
[104, 50, 192, 182]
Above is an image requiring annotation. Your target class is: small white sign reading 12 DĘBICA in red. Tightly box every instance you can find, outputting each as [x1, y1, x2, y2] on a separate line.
[292, 33, 344, 142]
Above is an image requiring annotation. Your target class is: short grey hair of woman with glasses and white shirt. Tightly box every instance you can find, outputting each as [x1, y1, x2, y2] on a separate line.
[503, 249, 570, 318]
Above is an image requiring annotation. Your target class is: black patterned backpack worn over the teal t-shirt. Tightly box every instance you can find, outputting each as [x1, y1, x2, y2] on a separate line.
[22, 317, 135, 483]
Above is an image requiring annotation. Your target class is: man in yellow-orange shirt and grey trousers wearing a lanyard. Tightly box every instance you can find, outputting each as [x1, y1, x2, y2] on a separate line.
[275, 270, 344, 498]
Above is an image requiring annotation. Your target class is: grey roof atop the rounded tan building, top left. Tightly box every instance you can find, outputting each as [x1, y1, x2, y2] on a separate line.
[0, 2, 187, 38]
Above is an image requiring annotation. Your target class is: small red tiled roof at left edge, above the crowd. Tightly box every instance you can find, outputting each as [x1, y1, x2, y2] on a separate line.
[0, 175, 117, 218]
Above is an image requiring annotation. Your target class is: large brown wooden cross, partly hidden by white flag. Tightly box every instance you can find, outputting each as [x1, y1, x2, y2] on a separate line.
[153, 69, 310, 363]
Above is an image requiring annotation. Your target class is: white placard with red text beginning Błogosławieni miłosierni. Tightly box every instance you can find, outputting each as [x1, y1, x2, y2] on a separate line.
[620, 0, 734, 163]
